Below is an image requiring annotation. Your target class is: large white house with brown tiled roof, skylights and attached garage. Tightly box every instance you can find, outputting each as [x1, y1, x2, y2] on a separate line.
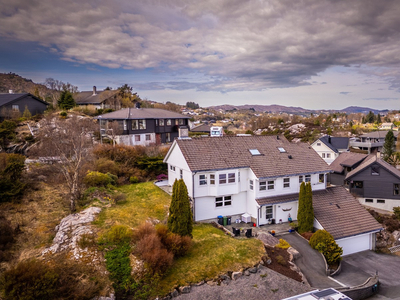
[164, 136, 380, 253]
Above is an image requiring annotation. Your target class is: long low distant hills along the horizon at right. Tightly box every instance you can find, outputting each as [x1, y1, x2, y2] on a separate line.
[207, 104, 388, 114]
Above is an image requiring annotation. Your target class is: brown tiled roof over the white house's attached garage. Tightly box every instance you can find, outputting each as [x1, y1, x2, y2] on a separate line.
[313, 186, 382, 239]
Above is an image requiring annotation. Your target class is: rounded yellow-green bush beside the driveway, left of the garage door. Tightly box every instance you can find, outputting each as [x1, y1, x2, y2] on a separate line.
[309, 230, 343, 265]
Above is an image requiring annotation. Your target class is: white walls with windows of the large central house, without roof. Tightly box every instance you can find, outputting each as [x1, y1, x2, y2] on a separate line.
[166, 143, 326, 225]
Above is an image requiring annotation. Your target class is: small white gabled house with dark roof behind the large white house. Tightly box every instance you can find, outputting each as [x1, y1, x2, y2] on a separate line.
[311, 135, 349, 164]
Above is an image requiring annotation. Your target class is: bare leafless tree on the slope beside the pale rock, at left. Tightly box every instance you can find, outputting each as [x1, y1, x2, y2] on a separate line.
[37, 116, 96, 212]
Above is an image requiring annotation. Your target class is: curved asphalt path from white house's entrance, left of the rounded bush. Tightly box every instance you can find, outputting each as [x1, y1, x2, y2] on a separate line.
[279, 233, 341, 289]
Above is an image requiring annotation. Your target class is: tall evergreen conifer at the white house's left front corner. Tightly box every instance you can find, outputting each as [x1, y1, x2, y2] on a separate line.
[167, 179, 193, 237]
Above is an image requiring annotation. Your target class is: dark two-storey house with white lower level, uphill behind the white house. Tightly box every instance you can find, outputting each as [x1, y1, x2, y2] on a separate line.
[96, 108, 190, 146]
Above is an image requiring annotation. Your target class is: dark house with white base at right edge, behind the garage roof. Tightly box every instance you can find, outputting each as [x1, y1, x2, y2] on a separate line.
[346, 154, 400, 211]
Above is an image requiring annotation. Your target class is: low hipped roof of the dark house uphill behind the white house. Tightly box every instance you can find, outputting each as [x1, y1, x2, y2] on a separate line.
[97, 108, 190, 120]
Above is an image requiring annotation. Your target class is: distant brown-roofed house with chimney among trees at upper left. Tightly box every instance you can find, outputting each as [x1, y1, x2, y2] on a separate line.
[74, 86, 121, 110]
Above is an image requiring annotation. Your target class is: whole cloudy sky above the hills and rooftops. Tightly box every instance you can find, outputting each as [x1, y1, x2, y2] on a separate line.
[0, 0, 400, 109]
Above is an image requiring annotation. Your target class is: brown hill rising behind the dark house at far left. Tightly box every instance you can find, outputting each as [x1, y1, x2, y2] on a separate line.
[0, 73, 59, 102]
